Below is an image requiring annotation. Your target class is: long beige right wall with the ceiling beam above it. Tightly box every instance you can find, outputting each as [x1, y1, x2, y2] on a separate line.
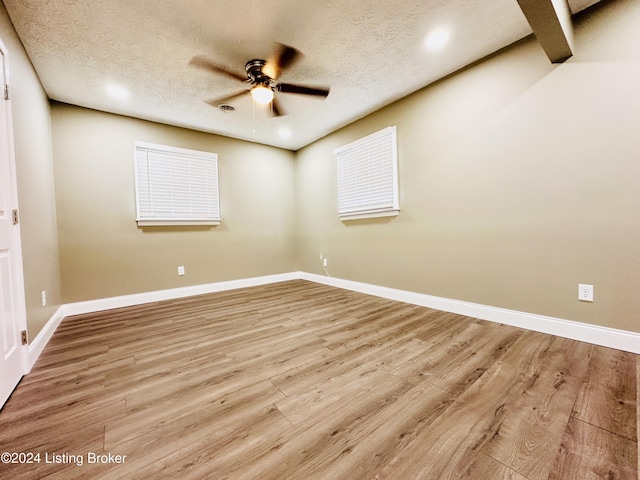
[297, 1, 640, 331]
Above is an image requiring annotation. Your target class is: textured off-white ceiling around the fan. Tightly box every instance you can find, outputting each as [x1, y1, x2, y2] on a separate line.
[3, 0, 597, 150]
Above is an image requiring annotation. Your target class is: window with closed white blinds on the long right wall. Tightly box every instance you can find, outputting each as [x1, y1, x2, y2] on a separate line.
[334, 126, 400, 220]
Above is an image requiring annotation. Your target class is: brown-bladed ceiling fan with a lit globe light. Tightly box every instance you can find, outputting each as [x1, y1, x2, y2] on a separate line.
[189, 43, 329, 117]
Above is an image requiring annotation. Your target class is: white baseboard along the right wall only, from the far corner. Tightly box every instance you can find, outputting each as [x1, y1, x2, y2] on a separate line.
[299, 272, 640, 353]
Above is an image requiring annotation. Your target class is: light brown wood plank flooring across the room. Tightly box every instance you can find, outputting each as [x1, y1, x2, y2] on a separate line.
[0, 281, 640, 480]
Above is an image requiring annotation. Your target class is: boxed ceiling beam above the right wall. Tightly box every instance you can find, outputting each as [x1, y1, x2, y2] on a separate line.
[518, 0, 573, 63]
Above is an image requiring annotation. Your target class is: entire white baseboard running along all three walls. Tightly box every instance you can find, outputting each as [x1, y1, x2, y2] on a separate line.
[26, 272, 640, 373]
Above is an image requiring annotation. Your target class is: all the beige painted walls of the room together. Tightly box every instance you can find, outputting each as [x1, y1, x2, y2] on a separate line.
[0, 0, 640, 338]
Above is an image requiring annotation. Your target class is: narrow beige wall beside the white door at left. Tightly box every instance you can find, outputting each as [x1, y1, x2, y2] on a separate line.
[0, 2, 62, 340]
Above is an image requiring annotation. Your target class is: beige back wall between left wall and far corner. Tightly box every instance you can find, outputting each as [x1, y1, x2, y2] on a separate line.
[52, 103, 296, 303]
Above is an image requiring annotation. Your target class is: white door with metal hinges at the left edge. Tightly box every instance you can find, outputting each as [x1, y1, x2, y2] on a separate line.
[0, 41, 26, 408]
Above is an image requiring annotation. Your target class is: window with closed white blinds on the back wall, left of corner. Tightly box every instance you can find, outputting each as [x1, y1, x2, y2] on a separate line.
[135, 142, 220, 226]
